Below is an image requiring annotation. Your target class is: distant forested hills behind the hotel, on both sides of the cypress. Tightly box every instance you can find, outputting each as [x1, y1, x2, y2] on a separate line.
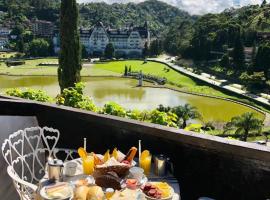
[0, 0, 192, 35]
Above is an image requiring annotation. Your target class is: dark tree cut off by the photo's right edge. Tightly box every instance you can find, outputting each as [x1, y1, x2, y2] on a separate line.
[254, 43, 270, 80]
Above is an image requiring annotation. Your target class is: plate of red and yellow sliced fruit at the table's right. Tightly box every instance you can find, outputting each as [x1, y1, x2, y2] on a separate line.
[141, 182, 174, 200]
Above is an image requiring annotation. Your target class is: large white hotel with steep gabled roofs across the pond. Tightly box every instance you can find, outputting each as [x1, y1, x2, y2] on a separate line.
[54, 22, 151, 57]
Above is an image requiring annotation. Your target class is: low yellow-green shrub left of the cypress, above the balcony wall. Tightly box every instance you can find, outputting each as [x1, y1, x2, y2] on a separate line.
[6, 88, 53, 102]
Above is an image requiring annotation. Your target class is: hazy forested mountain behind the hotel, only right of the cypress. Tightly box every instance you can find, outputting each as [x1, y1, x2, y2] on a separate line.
[79, 0, 194, 35]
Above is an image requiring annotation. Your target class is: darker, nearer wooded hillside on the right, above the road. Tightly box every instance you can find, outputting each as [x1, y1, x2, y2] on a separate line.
[166, 4, 270, 60]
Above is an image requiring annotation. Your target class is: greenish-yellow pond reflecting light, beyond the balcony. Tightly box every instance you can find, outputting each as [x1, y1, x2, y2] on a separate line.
[0, 76, 263, 121]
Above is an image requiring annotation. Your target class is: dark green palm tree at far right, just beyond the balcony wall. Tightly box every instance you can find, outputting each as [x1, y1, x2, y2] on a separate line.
[224, 112, 263, 142]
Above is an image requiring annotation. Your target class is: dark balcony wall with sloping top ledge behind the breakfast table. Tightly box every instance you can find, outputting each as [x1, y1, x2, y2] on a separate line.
[0, 96, 270, 200]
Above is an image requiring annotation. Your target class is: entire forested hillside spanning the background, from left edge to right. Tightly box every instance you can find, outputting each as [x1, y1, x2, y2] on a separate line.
[0, 0, 270, 60]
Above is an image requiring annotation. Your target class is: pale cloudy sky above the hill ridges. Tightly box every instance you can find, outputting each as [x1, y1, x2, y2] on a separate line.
[78, 0, 270, 15]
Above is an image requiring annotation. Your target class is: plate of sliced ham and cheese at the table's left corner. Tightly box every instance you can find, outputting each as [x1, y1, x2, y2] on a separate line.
[40, 182, 73, 200]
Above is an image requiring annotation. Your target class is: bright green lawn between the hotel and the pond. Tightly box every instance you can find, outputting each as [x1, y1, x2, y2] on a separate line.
[0, 58, 260, 99]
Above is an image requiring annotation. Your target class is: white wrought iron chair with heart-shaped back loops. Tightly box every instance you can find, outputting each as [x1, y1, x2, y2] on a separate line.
[2, 127, 76, 200]
